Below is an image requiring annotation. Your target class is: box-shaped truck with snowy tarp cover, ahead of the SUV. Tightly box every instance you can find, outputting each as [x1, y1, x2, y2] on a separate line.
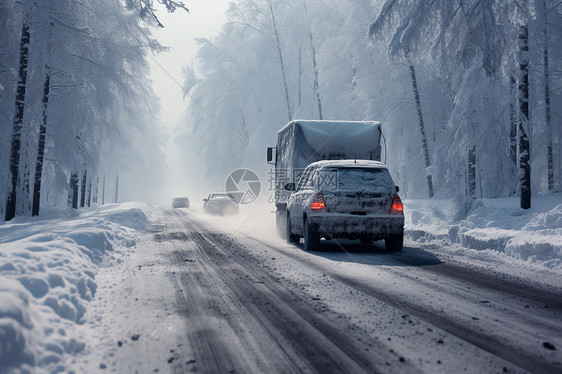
[267, 120, 382, 235]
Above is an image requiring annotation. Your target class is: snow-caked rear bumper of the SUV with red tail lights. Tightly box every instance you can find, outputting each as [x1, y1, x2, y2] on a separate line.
[309, 214, 404, 240]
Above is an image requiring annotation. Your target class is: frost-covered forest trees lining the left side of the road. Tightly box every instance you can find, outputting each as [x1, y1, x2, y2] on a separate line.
[0, 0, 171, 219]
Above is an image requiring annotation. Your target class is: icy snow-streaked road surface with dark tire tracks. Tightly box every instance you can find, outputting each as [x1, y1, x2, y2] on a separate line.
[72, 209, 562, 373]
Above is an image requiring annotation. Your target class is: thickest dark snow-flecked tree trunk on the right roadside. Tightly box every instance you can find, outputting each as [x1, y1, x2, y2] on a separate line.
[517, 23, 531, 209]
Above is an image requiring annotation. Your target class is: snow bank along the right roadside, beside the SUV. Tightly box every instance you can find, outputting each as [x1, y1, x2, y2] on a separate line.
[405, 194, 562, 270]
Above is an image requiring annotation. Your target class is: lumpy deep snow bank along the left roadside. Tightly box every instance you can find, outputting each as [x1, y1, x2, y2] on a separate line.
[0, 204, 150, 373]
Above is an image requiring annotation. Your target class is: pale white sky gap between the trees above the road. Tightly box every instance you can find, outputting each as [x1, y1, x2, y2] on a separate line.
[149, 0, 232, 204]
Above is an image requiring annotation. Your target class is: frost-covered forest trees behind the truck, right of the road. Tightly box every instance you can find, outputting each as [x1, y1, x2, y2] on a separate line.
[176, 0, 562, 205]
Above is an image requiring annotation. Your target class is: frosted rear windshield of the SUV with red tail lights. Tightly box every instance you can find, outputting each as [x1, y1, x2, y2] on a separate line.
[318, 168, 395, 194]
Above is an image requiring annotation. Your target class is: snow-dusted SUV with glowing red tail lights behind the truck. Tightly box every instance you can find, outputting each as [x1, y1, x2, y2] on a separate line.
[285, 160, 404, 252]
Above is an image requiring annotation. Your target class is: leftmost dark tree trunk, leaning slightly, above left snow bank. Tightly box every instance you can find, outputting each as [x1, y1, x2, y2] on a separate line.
[5, 14, 31, 221]
